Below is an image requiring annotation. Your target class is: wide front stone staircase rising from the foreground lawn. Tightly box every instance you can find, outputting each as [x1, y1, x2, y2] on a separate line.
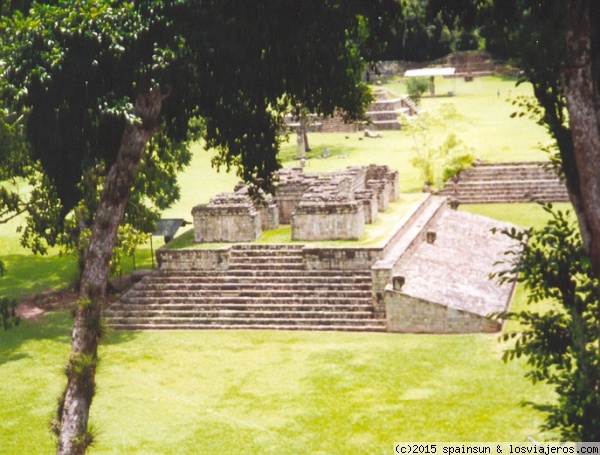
[107, 244, 386, 331]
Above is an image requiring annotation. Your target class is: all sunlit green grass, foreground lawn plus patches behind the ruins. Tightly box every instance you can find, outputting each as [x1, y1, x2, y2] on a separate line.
[0, 78, 564, 454]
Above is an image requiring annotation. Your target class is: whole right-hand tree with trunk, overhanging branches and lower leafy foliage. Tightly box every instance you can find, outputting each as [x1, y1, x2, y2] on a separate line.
[429, 0, 600, 441]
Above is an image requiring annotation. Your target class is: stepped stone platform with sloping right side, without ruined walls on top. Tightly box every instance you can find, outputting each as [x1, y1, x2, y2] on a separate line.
[107, 196, 513, 333]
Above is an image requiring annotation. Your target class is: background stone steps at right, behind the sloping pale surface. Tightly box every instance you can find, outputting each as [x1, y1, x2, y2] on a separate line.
[439, 162, 569, 204]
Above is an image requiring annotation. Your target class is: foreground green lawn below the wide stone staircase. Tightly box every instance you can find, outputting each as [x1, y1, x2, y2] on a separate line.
[0, 312, 547, 454]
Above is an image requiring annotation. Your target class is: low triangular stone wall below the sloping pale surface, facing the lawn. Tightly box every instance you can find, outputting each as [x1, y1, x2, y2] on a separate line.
[384, 285, 502, 333]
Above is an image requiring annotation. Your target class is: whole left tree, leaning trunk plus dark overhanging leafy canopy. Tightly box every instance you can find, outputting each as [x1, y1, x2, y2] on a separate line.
[0, 0, 408, 453]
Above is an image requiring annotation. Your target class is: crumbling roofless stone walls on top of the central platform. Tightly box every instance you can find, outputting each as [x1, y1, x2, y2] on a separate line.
[192, 164, 399, 242]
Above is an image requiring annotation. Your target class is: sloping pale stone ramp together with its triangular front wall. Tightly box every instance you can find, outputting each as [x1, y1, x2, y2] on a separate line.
[385, 210, 514, 333]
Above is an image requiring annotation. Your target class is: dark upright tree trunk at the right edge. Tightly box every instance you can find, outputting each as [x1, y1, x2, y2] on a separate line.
[565, 0, 600, 278]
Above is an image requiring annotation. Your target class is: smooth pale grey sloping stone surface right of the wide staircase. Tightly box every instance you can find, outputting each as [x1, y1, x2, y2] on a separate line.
[397, 210, 514, 316]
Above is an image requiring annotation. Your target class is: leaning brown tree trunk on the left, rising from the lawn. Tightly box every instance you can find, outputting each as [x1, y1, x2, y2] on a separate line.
[55, 88, 164, 455]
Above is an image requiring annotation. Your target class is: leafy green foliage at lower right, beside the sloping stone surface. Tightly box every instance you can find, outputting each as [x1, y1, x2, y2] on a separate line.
[498, 206, 600, 441]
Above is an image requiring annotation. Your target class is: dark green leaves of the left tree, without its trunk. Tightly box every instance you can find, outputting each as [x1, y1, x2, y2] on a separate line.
[0, 1, 401, 251]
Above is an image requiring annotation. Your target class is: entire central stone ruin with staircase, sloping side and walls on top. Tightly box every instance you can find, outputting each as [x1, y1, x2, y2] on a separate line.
[112, 165, 517, 333]
